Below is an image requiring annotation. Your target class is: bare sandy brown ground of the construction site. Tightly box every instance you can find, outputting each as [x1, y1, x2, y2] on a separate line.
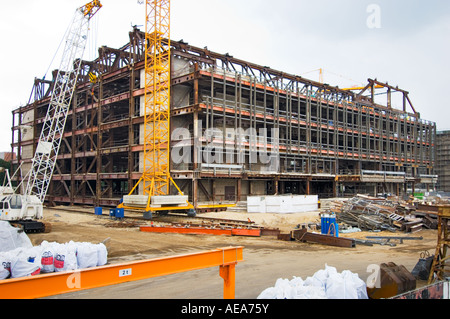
[29, 208, 437, 299]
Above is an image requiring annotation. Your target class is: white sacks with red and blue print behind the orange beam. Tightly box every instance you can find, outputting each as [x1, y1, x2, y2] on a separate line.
[0, 241, 108, 280]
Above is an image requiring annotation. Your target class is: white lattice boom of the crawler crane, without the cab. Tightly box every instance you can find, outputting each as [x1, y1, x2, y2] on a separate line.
[24, 0, 102, 203]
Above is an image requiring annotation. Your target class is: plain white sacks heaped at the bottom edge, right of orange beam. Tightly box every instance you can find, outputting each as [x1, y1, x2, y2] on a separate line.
[258, 265, 368, 299]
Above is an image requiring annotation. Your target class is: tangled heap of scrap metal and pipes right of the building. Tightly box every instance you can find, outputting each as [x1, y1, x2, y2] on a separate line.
[330, 195, 434, 233]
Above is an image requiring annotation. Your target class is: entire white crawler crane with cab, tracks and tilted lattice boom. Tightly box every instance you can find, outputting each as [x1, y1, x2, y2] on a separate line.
[0, 0, 102, 232]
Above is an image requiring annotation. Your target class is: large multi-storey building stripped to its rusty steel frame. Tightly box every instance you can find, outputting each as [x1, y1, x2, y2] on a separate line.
[12, 28, 436, 207]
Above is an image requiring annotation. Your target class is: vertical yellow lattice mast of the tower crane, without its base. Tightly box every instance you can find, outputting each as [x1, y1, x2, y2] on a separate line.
[142, 0, 171, 196]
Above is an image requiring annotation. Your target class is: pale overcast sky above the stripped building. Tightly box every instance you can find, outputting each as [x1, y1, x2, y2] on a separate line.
[0, 0, 450, 151]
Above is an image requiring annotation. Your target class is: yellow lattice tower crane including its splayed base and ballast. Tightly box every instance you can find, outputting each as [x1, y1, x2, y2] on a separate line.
[118, 0, 194, 218]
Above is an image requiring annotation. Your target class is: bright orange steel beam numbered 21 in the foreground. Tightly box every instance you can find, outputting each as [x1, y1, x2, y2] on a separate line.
[0, 246, 243, 299]
